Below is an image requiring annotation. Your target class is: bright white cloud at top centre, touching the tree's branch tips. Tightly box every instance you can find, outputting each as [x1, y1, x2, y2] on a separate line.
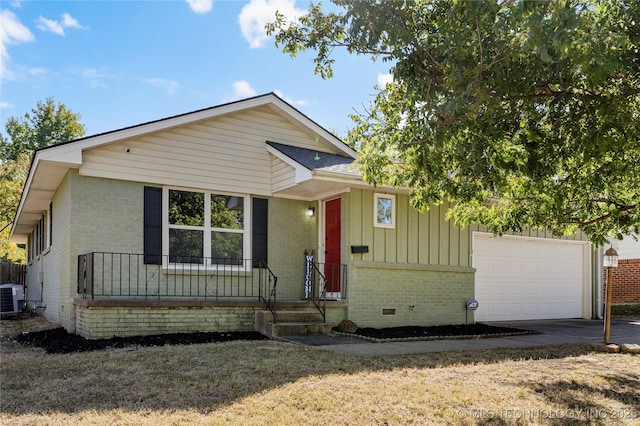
[238, 0, 307, 49]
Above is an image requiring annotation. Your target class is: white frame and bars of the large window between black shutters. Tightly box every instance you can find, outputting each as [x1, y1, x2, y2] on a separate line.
[162, 186, 251, 272]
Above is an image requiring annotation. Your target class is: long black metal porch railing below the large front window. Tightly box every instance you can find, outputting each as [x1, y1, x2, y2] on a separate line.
[77, 252, 277, 302]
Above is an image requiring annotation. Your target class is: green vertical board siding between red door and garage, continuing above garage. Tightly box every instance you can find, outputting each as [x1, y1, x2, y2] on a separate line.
[345, 189, 586, 267]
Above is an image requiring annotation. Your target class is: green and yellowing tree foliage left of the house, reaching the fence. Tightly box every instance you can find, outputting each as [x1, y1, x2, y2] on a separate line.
[0, 98, 85, 262]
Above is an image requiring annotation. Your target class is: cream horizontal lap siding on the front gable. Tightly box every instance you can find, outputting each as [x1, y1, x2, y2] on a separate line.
[80, 106, 336, 196]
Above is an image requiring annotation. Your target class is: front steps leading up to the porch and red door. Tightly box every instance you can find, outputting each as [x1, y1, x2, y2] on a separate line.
[255, 309, 331, 337]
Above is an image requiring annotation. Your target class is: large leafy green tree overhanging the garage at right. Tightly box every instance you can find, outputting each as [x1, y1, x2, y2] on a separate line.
[267, 0, 640, 244]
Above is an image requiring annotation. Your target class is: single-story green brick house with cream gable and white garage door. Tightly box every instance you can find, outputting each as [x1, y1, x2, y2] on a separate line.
[12, 93, 600, 338]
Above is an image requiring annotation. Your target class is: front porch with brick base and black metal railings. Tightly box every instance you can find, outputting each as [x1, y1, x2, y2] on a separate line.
[74, 252, 347, 339]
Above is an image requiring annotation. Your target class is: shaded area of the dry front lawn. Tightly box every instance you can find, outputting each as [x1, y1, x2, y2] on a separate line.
[0, 332, 608, 418]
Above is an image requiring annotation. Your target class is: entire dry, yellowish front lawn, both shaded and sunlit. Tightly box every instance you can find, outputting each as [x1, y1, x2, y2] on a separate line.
[0, 321, 640, 425]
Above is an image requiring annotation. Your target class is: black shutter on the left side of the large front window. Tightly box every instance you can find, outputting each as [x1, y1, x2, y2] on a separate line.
[144, 186, 162, 265]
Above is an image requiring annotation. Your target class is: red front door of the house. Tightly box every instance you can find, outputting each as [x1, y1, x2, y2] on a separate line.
[324, 198, 340, 293]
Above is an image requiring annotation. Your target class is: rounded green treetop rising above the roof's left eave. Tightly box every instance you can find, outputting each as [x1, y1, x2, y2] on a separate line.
[0, 98, 86, 161]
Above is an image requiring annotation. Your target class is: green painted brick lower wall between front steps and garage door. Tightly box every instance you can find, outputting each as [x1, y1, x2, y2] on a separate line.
[348, 262, 475, 328]
